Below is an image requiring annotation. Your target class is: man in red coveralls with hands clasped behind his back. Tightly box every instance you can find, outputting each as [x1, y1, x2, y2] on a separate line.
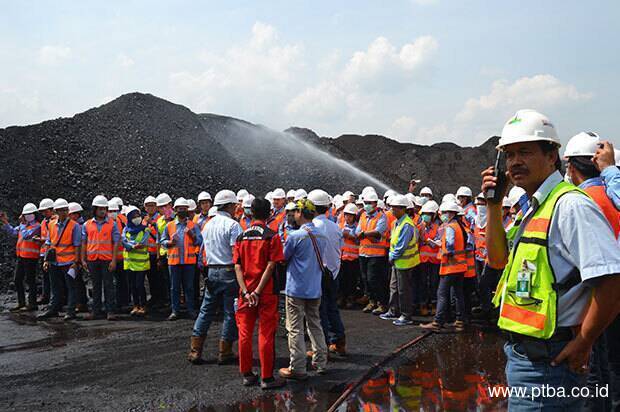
[233, 198, 285, 389]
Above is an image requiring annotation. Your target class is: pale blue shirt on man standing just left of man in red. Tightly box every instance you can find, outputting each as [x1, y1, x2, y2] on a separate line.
[202, 211, 243, 265]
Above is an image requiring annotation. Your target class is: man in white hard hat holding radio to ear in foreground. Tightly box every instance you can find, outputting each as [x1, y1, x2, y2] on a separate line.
[482, 110, 620, 410]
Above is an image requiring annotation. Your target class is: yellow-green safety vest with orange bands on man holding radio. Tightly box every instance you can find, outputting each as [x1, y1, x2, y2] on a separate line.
[493, 182, 587, 339]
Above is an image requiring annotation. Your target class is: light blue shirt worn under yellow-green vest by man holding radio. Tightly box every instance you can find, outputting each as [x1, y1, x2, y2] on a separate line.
[515, 171, 620, 326]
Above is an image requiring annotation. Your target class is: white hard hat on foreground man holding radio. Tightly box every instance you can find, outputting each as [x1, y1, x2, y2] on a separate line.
[497, 109, 562, 150]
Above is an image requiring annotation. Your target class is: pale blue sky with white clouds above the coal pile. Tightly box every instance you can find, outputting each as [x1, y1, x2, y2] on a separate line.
[0, 0, 620, 146]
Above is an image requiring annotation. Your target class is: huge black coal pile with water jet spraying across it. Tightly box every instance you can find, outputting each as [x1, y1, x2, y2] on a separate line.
[0, 93, 494, 291]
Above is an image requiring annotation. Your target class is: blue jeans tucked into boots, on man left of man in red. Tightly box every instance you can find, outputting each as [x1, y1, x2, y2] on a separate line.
[192, 269, 239, 342]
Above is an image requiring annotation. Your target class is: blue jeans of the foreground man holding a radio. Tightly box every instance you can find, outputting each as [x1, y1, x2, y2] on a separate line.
[504, 342, 587, 411]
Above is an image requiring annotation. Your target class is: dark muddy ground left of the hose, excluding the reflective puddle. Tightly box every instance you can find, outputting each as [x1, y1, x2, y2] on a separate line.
[0, 300, 438, 411]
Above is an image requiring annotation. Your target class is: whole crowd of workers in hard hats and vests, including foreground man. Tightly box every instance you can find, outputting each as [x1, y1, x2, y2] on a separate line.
[0, 110, 620, 405]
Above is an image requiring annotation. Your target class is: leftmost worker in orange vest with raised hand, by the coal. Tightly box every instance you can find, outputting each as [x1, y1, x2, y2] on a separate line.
[0, 203, 41, 312]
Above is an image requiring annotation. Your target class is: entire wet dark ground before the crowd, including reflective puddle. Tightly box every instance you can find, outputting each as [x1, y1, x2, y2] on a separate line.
[0, 296, 505, 412]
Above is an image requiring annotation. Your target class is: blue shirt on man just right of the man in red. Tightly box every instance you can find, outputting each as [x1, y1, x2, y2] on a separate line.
[284, 223, 326, 299]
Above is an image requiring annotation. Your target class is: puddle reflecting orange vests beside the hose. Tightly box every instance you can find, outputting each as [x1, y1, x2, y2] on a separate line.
[196, 330, 507, 412]
